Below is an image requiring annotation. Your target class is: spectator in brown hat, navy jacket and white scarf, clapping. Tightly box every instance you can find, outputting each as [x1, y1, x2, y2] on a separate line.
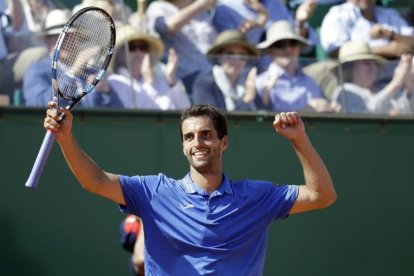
[193, 30, 260, 111]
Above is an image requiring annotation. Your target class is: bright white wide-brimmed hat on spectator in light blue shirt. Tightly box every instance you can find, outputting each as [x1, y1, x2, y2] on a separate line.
[257, 20, 310, 49]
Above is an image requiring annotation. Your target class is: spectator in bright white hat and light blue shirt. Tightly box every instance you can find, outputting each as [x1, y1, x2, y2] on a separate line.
[256, 20, 334, 112]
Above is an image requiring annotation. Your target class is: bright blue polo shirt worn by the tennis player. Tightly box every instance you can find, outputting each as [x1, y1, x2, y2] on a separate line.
[119, 174, 298, 276]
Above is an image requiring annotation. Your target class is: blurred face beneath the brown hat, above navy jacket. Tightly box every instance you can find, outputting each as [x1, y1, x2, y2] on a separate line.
[220, 45, 249, 78]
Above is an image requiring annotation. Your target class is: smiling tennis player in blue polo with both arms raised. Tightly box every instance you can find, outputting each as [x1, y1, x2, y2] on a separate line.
[44, 103, 336, 275]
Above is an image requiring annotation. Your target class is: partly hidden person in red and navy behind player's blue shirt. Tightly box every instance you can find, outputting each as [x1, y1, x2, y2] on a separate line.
[120, 215, 145, 276]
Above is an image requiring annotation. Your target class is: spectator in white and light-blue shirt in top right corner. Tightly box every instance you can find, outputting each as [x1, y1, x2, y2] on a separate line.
[320, 0, 414, 59]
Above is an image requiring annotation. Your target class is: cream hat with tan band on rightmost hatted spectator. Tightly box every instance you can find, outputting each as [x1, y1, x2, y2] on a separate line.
[338, 41, 387, 64]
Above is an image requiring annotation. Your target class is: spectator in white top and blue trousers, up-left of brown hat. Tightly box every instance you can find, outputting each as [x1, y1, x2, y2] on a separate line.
[147, 0, 217, 94]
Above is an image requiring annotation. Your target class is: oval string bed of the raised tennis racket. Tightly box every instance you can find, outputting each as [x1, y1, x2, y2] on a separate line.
[56, 10, 112, 98]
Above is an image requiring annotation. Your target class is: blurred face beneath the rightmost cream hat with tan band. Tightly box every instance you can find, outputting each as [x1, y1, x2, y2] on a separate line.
[351, 60, 379, 89]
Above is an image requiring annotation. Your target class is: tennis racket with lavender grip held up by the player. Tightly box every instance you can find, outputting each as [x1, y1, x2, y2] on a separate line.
[25, 7, 115, 188]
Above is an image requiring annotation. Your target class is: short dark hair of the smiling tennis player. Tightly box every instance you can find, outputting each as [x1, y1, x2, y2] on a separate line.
[180, 104, 227, 142]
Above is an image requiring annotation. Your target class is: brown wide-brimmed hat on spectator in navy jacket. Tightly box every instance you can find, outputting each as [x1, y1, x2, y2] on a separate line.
[207, 30, 260, 57]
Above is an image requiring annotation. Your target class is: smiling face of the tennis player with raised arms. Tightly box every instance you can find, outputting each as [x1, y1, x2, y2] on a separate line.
[181, 117, 227, 173]
